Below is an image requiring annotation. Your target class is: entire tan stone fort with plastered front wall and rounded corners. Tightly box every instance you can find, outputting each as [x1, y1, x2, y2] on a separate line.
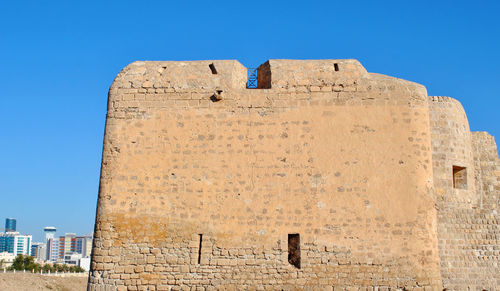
[88, 60, 500, 291]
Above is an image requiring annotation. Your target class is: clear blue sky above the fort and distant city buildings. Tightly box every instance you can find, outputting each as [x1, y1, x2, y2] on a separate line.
[0, 0, 500, 240]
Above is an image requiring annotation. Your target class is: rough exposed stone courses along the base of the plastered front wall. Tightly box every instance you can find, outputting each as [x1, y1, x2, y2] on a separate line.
[88, 240, 440, 291]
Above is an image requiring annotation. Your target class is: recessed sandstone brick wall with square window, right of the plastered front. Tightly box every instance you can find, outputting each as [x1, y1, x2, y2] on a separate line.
[429, 96, 500, 290]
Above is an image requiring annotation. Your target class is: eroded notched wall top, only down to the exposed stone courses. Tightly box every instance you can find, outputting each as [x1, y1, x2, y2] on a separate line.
[111, 60, 427, 101]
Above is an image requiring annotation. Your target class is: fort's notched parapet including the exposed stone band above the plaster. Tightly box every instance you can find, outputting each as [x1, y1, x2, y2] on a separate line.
[104, 60, 428, 119]
